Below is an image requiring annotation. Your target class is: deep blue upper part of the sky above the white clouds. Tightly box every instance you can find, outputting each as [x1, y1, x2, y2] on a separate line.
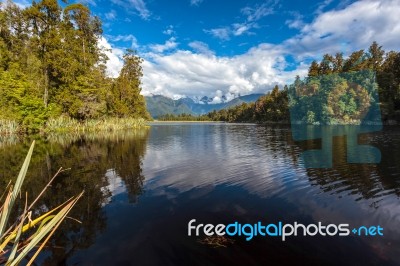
[100, 0, 338, 56]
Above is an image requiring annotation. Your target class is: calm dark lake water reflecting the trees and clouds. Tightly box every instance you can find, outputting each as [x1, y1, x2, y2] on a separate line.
[0, 123, 400, 265]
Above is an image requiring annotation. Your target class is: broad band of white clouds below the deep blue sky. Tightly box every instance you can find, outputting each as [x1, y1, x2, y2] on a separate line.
[102, 0, 400, 100]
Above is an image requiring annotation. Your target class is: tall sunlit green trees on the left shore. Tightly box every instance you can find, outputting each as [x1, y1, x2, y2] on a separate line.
[0, 0, 149, 131]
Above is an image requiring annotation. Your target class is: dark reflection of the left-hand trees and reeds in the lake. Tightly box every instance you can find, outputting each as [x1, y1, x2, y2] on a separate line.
[0, 130, 149, 265]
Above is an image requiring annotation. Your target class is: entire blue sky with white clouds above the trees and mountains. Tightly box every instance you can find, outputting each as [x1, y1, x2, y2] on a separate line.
[17, 0, 400, 102]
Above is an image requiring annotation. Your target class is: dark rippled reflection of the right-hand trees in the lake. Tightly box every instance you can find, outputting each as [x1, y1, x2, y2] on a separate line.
[293, 127, 400, 202]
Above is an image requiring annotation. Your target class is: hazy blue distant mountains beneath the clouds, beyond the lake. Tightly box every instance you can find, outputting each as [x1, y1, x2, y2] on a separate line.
[145, 94, 263, 118]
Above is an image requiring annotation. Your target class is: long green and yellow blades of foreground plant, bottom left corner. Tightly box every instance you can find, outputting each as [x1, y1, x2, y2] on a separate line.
[0, 142, 83, 265]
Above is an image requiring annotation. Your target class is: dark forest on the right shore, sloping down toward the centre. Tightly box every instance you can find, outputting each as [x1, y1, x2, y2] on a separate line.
[206, 42, 400, 124]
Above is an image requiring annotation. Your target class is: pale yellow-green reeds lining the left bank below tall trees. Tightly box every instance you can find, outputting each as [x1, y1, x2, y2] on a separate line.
[0, 116, 147, 136]
